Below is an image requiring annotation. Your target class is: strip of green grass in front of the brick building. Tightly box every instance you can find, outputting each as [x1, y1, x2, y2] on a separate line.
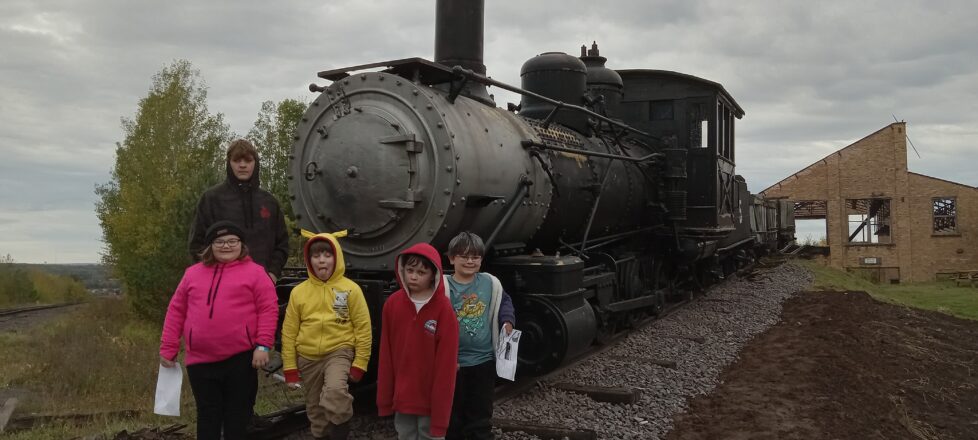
[798, 260, 978, 320]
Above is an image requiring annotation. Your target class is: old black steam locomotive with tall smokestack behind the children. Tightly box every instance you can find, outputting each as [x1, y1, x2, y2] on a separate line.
[280, 0, 793, 374]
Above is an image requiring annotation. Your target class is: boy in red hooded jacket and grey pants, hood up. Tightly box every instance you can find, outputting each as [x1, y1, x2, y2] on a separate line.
[377, 243, 458, 440]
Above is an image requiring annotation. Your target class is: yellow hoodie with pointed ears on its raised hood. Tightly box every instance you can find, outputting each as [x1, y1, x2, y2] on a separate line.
[282, 231, 372, 373]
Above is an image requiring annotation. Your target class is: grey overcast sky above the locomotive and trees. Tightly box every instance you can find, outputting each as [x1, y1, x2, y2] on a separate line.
[0, 0, 978, 263]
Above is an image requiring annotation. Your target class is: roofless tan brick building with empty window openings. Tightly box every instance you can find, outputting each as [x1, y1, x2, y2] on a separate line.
[761, 122, 978, 282]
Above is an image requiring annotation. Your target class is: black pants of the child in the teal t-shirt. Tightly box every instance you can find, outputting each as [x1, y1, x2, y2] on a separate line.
[445, 359, 496, 440]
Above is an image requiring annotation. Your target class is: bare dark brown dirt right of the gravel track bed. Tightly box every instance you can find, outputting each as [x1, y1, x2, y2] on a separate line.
[668, 292, 978, 439]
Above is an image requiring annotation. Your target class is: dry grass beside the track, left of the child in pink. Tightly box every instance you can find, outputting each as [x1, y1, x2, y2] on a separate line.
[0, 299, 303, 440]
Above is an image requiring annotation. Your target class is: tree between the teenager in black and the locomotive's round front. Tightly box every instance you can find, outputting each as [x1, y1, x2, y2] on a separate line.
[248, 99, 307, 265]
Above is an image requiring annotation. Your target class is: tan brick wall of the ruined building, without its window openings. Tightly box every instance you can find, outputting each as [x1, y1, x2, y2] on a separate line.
[761, 122, 978, 282]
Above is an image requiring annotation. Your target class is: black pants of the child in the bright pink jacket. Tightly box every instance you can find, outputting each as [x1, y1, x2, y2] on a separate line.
[187, 350, 258, 440]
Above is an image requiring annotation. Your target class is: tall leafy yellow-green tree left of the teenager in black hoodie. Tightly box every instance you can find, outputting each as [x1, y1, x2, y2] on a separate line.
[95, 60, 231, 320]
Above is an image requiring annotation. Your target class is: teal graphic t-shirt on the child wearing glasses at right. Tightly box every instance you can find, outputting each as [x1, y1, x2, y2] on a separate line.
[448, 273, 495, 367]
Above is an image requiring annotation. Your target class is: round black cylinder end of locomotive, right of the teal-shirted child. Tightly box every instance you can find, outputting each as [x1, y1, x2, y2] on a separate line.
[513, 295, 567, 376]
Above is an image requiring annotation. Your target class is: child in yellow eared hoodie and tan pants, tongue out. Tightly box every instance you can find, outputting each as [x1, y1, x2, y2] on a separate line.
[282, 231, 372, 440]
